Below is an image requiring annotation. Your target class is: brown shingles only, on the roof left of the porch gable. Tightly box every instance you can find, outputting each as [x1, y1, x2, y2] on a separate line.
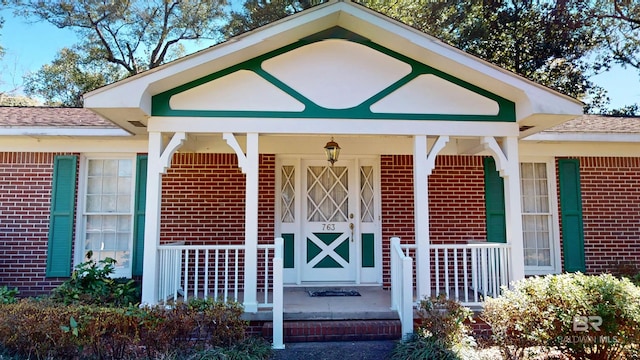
[0, 106, 119, 129]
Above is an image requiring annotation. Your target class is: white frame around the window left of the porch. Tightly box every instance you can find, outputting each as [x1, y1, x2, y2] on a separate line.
[73, 153, 138, 278]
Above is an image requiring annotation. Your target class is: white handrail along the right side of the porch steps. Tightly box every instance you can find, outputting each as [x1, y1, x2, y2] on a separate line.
[391, 237, 413, 337]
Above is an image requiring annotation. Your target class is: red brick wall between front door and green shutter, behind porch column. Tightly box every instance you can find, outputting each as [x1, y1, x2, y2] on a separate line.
[380, 155, 486, 286]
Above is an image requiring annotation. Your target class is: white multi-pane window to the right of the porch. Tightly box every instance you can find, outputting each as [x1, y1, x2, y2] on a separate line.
[520, 162, 559, 275]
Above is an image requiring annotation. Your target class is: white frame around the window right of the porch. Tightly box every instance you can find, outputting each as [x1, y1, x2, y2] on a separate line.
[518, 156, 561, 276]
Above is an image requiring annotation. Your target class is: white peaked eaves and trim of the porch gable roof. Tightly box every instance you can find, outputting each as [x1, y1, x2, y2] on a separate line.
[84, 1, 582, 135]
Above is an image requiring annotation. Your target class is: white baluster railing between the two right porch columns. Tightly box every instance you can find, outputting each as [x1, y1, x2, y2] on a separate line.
[429, 242, 511, 306]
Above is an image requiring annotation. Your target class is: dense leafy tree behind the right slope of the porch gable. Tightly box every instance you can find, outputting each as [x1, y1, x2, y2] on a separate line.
[363, 0, 600, 99]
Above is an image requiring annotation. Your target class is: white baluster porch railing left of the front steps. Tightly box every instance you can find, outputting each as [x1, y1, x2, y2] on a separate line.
[158, 243, 275, 308]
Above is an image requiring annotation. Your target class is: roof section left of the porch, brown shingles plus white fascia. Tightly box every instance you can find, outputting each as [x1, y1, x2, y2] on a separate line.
[0, 106, 130, 136]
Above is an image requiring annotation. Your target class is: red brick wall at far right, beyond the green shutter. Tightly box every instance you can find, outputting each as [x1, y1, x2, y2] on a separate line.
[568, 157, 640, 274]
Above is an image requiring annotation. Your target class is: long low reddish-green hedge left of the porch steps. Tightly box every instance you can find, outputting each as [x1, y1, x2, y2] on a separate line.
[0, 299, 270, 359]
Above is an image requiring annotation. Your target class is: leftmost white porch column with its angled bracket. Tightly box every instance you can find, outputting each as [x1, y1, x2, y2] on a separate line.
[141, 132, 186, 305]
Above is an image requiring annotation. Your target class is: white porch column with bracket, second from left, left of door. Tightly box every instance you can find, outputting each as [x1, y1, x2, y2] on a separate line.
[222, 133, 260, 313]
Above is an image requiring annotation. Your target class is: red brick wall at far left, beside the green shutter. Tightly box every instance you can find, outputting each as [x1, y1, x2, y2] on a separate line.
[0, 153, 71, 296]
